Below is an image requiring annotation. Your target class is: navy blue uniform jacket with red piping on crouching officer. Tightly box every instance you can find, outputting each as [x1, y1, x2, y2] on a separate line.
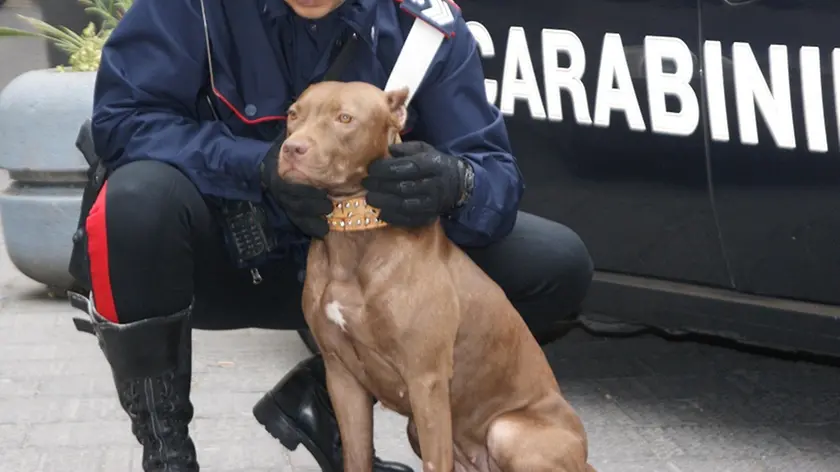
[93, 0, 524, 254]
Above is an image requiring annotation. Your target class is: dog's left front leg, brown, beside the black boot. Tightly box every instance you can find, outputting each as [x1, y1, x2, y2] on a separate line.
[324, 355, 373, 472]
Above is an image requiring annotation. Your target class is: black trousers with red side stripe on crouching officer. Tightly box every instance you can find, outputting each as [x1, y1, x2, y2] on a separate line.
[85, 161, 593, 334]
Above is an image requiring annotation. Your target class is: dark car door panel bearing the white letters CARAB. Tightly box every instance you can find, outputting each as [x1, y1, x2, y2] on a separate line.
[458, 0, 730, 287]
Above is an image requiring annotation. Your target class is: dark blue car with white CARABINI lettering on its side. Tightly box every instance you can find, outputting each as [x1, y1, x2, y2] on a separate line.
[459, 0, 840, 355]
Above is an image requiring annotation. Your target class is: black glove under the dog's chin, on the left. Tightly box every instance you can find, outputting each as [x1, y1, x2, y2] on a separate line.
[261, 145, 333, 239]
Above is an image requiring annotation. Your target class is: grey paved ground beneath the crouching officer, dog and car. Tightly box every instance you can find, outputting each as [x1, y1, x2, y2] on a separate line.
[0, 0, 840, 472]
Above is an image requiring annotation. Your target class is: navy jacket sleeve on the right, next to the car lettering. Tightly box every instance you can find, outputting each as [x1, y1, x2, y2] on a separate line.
[412, 12, 525, 246]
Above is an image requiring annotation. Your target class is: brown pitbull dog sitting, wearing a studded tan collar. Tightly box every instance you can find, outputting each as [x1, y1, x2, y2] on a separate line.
[278, 82, 594, 472]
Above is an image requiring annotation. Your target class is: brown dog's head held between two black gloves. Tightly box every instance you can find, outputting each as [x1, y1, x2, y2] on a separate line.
[277, 82, 408, 197]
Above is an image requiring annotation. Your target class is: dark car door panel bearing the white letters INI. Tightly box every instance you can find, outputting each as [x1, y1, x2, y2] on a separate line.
[701, 0, 840, 304]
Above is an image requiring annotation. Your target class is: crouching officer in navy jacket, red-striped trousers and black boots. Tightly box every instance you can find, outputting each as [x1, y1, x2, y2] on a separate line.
[71, 0, 592, 472]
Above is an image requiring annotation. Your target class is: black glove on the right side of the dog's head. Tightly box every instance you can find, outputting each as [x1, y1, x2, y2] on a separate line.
[362, 141, 472, 227]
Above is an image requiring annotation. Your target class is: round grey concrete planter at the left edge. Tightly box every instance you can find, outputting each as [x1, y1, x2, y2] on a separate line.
[0, 69, 95, 293]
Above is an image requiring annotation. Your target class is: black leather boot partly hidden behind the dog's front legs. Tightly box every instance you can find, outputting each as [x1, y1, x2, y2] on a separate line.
[254, 355, 414, 472]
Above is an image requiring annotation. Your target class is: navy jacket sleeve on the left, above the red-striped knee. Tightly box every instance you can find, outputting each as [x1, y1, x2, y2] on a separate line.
[92, 0, 271, 201]
